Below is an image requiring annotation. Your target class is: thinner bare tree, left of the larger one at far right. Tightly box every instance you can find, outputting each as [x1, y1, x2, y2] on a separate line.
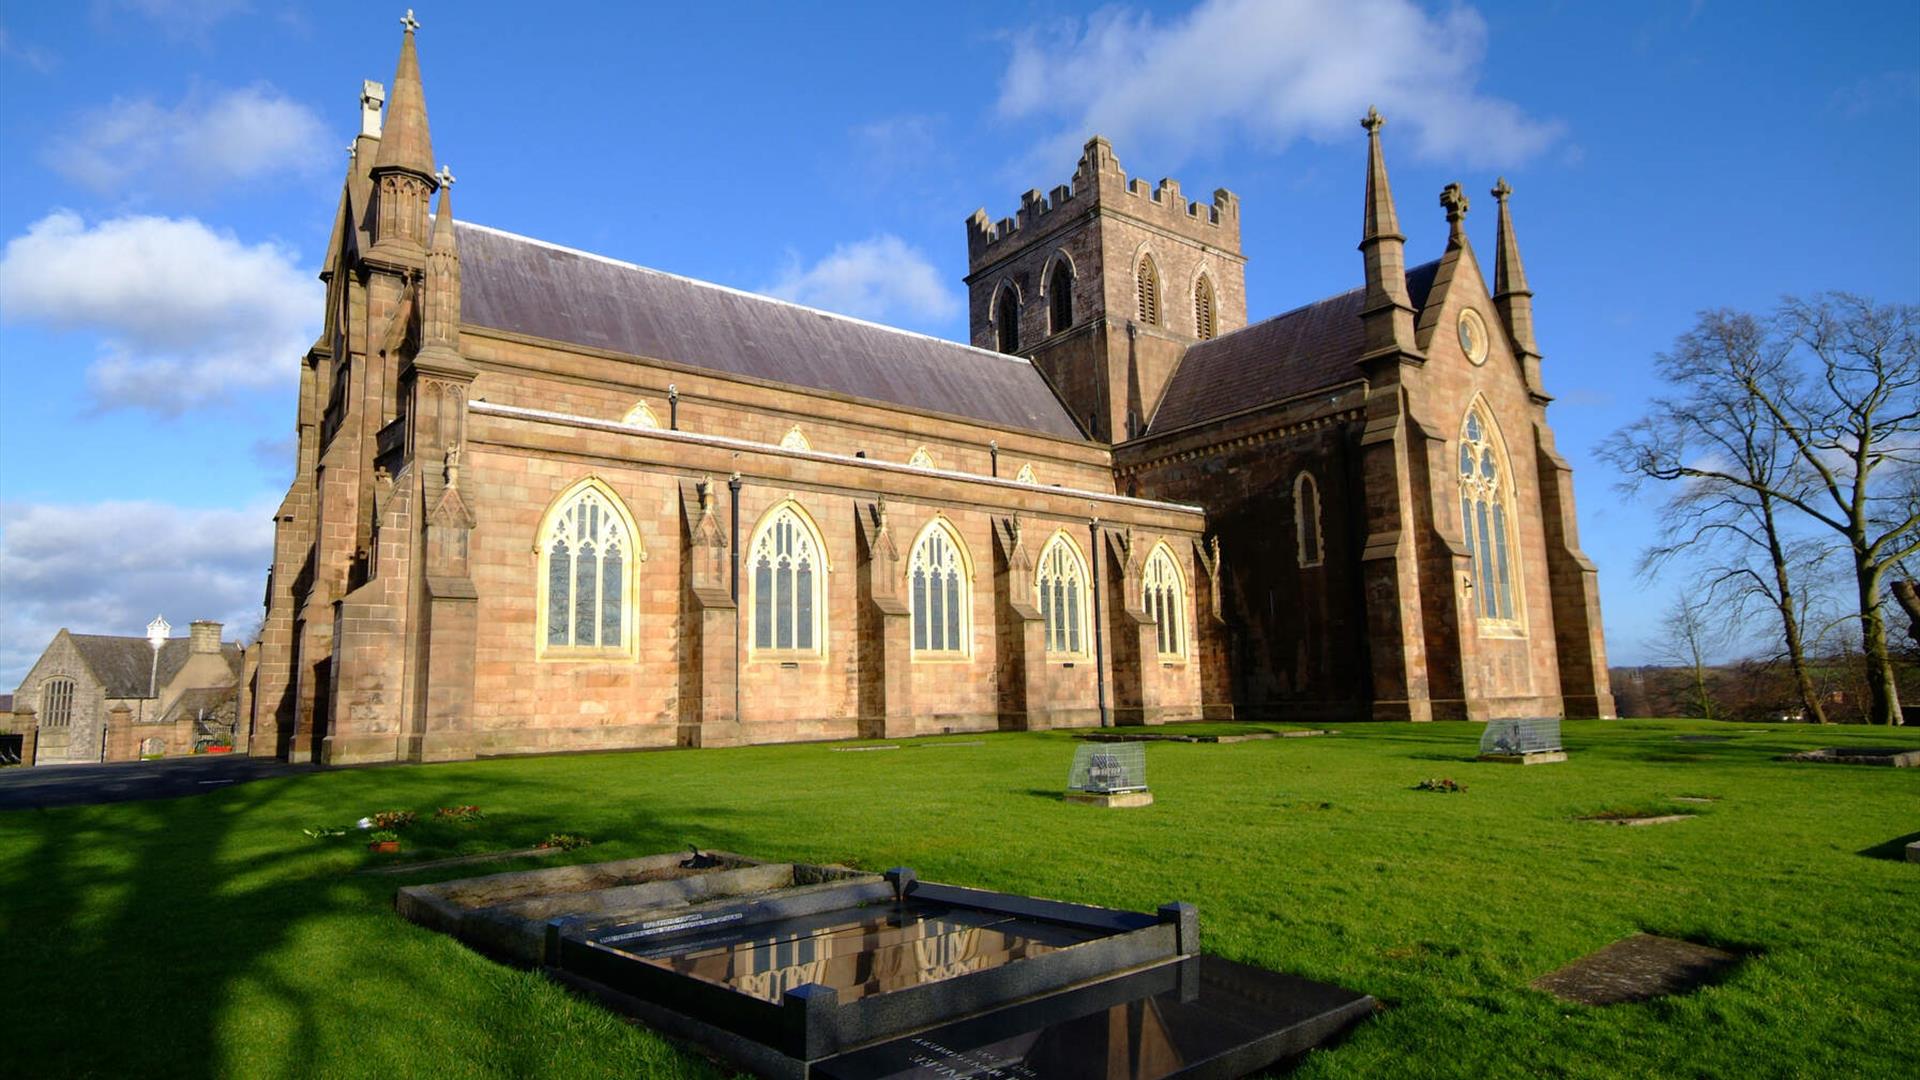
[1599, 311, 1826, 723]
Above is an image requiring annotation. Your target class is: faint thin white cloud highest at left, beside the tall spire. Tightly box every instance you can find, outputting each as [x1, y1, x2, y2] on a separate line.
[44, 85, 334, 194]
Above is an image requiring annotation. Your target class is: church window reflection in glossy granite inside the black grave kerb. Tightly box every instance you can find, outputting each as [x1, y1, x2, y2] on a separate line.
[599, 899, 1096, 1001]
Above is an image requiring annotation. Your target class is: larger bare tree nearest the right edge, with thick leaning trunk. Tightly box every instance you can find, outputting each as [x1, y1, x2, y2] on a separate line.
[1620, 292, 1920, 724]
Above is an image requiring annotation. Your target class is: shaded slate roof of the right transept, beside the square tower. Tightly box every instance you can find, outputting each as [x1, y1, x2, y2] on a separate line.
[1148, 259, 1440, 432]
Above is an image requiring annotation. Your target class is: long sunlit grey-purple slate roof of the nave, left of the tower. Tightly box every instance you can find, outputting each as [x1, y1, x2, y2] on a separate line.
[455, 221, 1085, 440]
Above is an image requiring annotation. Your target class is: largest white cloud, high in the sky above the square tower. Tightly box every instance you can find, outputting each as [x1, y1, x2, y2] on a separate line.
[1000, 0, 1561, 167]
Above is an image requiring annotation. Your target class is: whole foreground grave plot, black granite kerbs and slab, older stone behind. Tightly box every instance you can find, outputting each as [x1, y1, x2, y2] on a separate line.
[415, 855, 1373, 1080]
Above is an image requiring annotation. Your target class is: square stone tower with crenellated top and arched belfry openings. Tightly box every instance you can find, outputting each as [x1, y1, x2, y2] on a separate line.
[966, 136, 1246, 442]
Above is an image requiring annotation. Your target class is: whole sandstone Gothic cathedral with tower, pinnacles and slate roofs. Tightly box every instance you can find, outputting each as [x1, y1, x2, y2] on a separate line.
[242, 15, 1613, 763]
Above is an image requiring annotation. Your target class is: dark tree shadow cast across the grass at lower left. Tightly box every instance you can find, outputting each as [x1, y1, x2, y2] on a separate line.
[0, 771, 743, 1076]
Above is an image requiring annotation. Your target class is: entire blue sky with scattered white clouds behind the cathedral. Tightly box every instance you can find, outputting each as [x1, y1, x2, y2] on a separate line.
[0, 0, 1920, 686]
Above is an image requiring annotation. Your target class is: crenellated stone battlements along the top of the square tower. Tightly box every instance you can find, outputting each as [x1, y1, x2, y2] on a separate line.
[966, 135, 1240, 269]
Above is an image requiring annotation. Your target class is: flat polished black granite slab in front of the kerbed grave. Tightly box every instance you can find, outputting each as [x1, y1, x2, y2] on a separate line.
[810, 957, 1373, 1080]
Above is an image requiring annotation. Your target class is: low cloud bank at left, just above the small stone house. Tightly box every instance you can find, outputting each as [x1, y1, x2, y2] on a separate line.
[0, 502, 273, 692]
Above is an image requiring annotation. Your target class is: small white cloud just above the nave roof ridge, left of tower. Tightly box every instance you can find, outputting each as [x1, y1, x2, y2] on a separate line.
[760, 234, 960, 323]
